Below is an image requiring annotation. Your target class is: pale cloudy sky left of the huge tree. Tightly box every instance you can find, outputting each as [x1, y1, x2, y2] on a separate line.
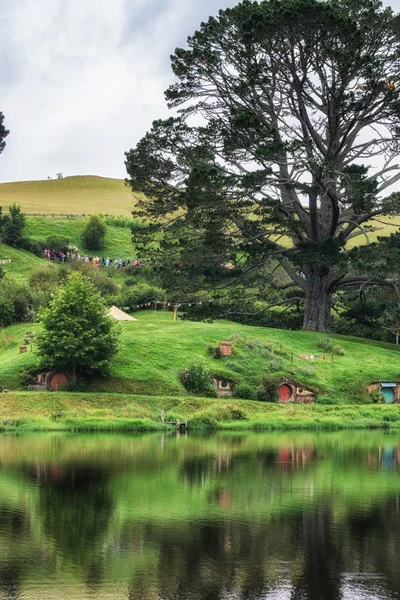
[0, 0, 236, 182]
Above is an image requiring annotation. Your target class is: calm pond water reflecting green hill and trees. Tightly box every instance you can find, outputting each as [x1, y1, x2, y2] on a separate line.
[0, 433, 400, 600]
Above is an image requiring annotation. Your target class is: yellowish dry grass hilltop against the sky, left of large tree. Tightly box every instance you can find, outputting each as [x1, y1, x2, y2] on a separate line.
[0, 175, 139, 215]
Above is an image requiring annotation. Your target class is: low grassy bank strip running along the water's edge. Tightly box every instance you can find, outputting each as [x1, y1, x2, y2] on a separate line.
[0, 392, 400, 432]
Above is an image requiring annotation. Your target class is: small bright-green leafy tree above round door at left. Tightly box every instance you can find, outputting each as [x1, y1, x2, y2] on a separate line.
[37, 273, 119, 380]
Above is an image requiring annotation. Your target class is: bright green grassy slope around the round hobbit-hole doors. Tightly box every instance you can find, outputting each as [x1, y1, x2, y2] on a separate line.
[0, 311, 400, 404]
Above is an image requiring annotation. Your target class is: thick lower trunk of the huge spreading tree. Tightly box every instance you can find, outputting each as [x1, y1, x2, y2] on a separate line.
[303, 267, 332, 332]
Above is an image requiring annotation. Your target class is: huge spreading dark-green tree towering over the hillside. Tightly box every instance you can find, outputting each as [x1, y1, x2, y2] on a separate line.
[126, 0, 400, 331]
